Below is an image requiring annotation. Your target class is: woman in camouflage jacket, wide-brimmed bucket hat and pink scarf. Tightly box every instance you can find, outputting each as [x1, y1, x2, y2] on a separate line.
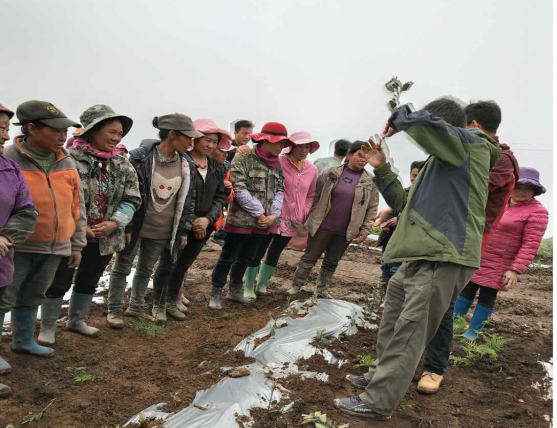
[39, 105, 141, 346]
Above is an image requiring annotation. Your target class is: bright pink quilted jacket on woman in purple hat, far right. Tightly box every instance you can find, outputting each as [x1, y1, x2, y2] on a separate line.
[472, 200, 549, 291]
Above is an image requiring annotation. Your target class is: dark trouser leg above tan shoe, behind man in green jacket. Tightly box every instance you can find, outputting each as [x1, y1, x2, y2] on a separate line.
[424, 302, 454, 376]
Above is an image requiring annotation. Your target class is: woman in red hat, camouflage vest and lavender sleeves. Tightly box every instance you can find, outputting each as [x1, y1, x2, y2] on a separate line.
[209, 122, 293, 310]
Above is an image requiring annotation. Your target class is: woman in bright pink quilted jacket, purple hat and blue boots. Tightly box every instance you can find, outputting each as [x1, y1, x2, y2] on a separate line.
[455, 168, 549, 341]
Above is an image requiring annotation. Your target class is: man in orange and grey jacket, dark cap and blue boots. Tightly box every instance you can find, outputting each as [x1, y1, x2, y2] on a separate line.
[0, 101, 87, 364]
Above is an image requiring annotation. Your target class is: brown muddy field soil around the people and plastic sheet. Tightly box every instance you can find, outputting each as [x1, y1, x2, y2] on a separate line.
[0, 242, 553, 428]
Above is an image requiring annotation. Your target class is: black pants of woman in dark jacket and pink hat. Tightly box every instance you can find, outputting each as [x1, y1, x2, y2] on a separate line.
[154, 226, 214, 303]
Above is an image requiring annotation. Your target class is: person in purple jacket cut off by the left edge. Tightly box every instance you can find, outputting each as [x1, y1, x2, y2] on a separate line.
[0, 104, 39, 398]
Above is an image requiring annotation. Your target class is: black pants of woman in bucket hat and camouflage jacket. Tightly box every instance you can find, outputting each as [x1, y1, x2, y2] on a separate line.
[46, 242, 113, 299]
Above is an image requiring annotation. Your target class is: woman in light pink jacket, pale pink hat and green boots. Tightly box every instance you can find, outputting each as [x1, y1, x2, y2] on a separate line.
[244, 132, 319, 299]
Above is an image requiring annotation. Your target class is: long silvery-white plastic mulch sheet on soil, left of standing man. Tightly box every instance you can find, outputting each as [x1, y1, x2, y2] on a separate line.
[124, 300, 375, 428]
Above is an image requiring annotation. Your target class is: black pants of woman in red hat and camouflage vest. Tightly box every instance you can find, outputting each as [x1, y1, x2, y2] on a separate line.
[213, 233, 267, 288]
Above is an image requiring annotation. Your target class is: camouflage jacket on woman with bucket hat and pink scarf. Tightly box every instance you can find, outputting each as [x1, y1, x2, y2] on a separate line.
[68, 149, 142, 256]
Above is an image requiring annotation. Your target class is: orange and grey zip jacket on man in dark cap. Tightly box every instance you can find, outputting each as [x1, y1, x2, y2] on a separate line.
[4, 143, 87, 257]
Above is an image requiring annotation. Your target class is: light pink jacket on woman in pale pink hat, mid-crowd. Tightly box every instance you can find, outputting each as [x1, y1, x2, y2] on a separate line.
[271, 155, 317, 238]
